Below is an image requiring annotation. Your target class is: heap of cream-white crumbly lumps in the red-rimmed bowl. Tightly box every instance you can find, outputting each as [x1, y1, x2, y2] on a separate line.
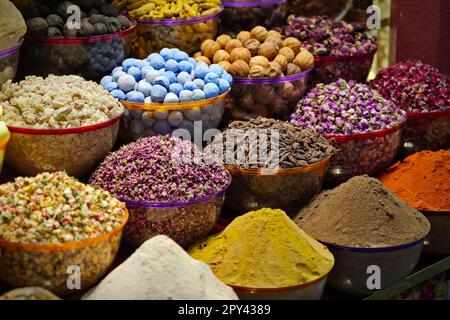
[0, 75, 124, 129]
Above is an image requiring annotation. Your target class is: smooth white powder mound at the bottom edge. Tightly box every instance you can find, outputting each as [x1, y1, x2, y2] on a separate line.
[83, 235, 237, 300]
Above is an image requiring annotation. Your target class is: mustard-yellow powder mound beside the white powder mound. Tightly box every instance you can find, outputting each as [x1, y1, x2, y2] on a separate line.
[189, 209, 334, 288]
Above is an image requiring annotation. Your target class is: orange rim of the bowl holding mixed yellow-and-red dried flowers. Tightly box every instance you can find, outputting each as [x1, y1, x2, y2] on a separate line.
[0, 207, 129, 252]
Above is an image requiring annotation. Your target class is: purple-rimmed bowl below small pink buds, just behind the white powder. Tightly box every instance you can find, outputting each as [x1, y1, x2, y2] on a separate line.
[122, 177, 231, 248]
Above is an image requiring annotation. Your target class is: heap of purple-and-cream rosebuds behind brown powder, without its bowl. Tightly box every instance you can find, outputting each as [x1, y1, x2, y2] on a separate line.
[291, 79, 406, 135]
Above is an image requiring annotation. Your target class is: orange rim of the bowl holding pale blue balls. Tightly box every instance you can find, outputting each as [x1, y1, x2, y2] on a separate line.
[119, 89, 231, 111]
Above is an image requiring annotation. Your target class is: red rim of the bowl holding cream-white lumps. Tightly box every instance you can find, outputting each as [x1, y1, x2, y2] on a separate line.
[6, 112, 123, 136]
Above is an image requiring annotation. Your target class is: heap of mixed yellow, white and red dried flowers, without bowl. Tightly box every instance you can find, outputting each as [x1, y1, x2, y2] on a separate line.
[0, 172, 128, 243]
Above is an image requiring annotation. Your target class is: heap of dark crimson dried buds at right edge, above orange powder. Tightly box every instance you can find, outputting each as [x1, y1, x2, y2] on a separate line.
[370, 60, 450, 113]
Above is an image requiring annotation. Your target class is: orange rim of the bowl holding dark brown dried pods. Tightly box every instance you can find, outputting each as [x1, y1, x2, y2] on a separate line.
[226, 156, 332, 176]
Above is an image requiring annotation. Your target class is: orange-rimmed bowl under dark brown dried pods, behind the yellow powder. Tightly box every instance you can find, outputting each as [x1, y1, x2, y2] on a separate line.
[225, 158, 330, 216]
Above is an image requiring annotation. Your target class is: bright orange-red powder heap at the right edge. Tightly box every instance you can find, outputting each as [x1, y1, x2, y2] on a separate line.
[379, 150, 450, 211]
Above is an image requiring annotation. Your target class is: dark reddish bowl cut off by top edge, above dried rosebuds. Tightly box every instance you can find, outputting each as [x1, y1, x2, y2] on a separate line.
[289, 0, 352, 20]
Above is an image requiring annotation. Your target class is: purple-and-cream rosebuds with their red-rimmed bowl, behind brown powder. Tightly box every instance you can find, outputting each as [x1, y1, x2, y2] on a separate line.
[291, 79, 406, 184]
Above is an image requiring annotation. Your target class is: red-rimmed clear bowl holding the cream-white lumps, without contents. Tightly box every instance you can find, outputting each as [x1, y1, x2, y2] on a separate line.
[6, 115, 121, 178]
